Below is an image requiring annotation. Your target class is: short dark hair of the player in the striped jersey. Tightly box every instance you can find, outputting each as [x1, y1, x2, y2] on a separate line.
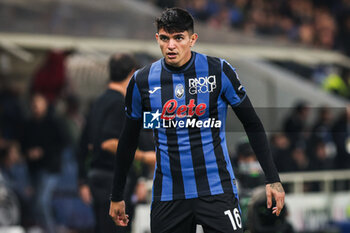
[155, 7, 194, 33]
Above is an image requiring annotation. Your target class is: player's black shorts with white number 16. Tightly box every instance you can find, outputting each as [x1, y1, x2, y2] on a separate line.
[151, 194, 243, 233]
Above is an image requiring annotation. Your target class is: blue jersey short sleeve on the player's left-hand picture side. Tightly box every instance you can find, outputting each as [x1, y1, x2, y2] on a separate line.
[125, 72, 142, 120]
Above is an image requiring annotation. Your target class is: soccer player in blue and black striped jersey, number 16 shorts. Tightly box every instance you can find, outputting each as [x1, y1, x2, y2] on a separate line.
[110, 8, 285, 233]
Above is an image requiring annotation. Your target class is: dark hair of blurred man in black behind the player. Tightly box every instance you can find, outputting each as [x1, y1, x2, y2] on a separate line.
[108, 53, 138, 82]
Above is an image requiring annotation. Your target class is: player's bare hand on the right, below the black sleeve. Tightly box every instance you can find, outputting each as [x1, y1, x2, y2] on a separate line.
[266, 182, 285, 216]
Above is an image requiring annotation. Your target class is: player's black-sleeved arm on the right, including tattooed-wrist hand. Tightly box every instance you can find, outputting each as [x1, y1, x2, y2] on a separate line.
[233, 96, 285, 216]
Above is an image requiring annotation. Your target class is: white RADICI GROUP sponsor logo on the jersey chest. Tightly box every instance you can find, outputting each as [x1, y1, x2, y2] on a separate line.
[188, 75, 216, 95]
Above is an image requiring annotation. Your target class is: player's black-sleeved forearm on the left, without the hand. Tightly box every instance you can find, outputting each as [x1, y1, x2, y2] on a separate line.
[111, 117, 141, 202]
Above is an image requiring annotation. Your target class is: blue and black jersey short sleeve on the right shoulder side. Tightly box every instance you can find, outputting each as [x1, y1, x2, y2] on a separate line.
[222, 60, 246, 107]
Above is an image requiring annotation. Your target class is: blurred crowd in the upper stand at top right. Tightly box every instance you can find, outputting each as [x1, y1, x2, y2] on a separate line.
[156, 0, 350, 56]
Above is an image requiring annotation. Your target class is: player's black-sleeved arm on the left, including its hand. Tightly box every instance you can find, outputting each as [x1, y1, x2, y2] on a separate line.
[109, 117, 141, 226]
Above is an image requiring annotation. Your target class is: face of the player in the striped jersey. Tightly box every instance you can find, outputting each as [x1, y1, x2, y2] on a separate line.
[156, 29, 198, 67]
